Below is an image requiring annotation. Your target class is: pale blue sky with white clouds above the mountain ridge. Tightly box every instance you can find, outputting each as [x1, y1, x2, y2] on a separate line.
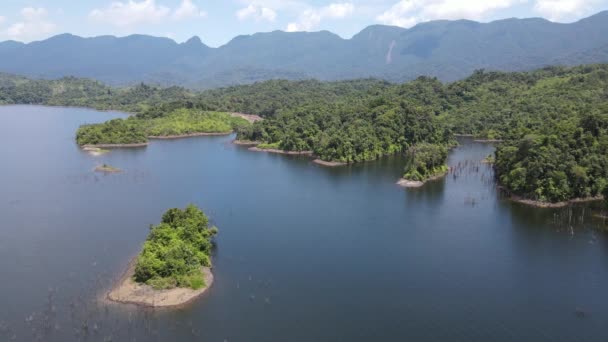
[0, 0, 608, 47]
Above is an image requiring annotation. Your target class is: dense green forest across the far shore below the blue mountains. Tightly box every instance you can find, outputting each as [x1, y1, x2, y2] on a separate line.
[0, 64, 608, 202]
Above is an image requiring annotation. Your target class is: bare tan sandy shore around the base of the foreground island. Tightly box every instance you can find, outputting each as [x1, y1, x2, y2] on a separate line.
[107, 259, 213, 308]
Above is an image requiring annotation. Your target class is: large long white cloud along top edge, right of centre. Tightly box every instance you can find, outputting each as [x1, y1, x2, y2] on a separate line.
[376, 0, 524, 27]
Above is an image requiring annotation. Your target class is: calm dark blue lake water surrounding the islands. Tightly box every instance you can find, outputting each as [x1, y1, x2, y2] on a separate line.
[0, 106, 608, 342]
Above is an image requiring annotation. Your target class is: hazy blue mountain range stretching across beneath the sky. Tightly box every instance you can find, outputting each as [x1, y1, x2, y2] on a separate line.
[0, 11, 608, 88]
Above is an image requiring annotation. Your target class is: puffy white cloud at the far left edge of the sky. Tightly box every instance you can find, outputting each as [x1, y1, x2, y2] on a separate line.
[2, 7, 57, 41]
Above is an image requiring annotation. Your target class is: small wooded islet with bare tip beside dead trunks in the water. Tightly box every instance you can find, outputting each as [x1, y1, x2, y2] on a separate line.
[397, 143, 449, 188]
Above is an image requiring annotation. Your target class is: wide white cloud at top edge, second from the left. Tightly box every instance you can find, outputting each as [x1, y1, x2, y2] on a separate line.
[89, 0, 207, 28]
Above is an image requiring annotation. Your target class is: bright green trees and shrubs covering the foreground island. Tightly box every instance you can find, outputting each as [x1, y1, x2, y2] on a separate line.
[135, 205, 217, 289]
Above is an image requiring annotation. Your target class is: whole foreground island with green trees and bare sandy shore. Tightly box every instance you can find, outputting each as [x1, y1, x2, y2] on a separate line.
[108, 205, 217, 307]
